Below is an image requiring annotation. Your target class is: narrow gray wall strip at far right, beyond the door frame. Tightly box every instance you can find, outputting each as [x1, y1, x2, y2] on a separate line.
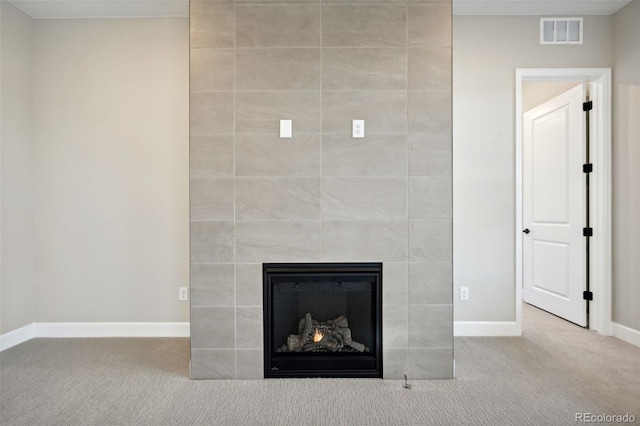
[613, 1, 640, 331]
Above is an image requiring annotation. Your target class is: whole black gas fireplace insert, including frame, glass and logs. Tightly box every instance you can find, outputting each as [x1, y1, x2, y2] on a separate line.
[263, 263, 382, 378]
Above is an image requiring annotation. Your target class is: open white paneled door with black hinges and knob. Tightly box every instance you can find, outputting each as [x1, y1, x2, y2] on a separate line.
[522, 85, 587, 327]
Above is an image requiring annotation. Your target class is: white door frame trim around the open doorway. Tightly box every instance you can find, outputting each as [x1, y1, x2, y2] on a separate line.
[515, 68, 612, 336]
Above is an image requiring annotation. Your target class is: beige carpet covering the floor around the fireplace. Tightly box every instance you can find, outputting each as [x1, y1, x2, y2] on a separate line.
[0, 306, 640, 425]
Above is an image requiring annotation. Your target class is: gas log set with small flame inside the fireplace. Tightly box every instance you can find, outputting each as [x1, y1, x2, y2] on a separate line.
[278, 313, 369, 352]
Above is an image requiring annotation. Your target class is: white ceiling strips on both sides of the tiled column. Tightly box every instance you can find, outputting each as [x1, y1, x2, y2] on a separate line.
[6, 0, 638, 18]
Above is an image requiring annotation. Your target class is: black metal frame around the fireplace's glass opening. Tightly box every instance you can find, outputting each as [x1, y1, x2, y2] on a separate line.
[263, 262, 382, 378]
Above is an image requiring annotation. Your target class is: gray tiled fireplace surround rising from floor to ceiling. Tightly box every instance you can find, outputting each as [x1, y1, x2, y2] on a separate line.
[190, 0, 453, 379]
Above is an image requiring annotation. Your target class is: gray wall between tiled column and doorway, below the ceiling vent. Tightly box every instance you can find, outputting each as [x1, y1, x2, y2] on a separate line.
[453, 16, 612, 321]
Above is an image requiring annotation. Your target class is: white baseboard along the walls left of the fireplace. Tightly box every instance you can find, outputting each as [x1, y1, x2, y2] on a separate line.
[0, 322, 190, 351]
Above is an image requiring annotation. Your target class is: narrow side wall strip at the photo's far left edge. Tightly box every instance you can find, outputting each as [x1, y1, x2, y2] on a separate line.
[0, 1, 35, 334]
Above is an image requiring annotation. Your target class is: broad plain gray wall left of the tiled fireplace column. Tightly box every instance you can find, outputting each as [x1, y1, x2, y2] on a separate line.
[33, 18, 189, 322]
